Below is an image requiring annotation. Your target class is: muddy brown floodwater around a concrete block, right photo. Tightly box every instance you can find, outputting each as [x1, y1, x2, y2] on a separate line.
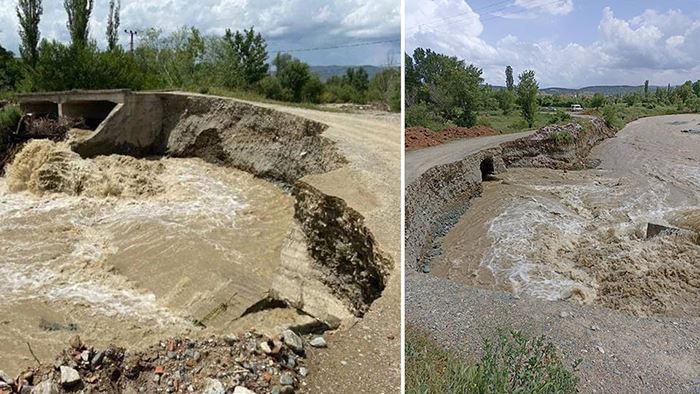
[434, 115, 700, 316]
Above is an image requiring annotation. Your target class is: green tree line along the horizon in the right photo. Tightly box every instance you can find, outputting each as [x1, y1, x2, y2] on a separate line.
[405, 48, 700, 129]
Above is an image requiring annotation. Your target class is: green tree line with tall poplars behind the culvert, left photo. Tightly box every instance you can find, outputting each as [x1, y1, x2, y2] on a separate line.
[0, 0, 401, 111]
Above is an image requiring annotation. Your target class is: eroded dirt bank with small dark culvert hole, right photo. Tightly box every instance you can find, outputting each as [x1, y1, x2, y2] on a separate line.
[406, 119, 615, 271]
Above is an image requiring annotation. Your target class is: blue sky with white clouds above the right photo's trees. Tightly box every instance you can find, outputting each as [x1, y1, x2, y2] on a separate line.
[405, 0, 700, 88]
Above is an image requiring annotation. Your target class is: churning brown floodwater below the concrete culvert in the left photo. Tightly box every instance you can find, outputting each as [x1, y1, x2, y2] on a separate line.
[0, 141, 293, 373]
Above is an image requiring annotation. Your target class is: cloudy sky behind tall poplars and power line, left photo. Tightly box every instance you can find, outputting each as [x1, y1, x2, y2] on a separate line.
[0, 0, 401, 65]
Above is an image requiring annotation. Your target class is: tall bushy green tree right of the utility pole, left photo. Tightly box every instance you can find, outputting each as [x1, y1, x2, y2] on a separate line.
[224, 27, 269, 86]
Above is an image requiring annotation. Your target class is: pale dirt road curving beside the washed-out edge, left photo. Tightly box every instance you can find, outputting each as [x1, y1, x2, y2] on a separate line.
[235, 103, 402, 394]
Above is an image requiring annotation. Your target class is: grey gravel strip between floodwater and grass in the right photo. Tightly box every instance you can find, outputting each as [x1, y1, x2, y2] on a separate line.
[406, 273, 700, 393]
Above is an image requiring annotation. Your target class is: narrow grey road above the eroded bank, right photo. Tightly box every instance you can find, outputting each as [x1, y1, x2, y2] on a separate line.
[406, 131, 534, 184]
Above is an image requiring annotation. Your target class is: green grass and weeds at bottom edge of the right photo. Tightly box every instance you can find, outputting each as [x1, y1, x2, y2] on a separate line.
[406, 326, 580, 394]
